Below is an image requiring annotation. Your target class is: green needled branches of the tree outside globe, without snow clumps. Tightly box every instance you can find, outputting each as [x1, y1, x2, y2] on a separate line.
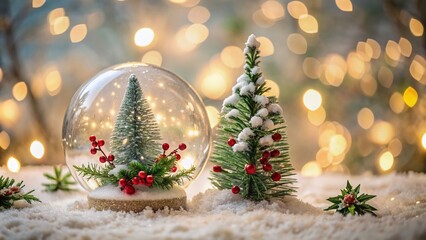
[211, 38, 295, 201]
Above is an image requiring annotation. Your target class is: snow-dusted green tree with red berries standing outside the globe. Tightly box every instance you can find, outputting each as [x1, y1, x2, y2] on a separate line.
[211, 34, 295, 201]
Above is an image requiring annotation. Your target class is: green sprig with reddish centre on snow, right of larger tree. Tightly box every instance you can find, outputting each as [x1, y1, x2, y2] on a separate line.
[324, 181, 377, 216]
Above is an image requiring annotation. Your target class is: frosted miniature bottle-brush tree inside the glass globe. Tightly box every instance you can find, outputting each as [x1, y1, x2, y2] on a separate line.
[111, 74, 161, 165]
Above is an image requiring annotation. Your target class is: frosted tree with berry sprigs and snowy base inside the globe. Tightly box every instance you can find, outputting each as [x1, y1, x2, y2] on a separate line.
[73, 74, 195, 212]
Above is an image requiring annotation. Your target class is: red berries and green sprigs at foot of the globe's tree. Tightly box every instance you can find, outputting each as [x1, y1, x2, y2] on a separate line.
[74, 136, 195, 195]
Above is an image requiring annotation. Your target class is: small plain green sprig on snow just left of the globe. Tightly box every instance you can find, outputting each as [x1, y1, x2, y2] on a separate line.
[43, 166, 76, 192]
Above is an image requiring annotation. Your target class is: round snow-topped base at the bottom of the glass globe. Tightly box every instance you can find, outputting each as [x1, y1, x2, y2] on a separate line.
[87, 185, 186, 212]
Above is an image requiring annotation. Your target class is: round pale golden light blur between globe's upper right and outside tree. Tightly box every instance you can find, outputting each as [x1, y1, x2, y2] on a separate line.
[201, 73, 227, 100]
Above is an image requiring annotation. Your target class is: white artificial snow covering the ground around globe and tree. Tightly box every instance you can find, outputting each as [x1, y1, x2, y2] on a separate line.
[0, 167, 426, 240]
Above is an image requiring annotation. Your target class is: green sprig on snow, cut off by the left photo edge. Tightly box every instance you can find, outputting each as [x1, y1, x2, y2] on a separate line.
[0, 176, 40, 210]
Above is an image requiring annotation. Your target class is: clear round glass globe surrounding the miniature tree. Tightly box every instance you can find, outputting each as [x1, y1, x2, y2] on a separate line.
[62, 63, 211, 191]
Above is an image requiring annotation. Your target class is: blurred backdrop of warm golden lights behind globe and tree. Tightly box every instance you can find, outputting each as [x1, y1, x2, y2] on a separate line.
[0, 0, 426, 176]
